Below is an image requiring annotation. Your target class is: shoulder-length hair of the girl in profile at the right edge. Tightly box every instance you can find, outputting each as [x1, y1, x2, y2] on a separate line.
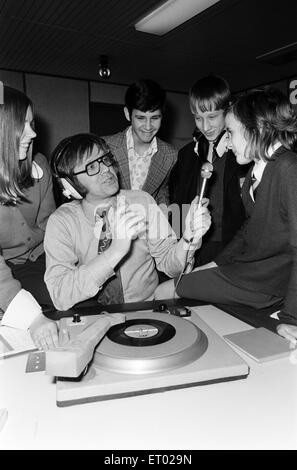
[227, 87, 297, 161]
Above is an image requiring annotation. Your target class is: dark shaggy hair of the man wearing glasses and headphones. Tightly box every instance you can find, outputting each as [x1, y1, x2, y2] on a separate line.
[50, 134, 115, 196]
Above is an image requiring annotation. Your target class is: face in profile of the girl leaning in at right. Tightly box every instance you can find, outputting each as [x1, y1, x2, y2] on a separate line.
[225, 113, 252, 165]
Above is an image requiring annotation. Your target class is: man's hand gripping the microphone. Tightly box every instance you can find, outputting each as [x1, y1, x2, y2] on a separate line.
[183, 196, 211, 244]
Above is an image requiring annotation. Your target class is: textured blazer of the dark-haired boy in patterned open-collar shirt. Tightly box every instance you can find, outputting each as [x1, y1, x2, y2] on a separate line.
[103, 129, 177, 205]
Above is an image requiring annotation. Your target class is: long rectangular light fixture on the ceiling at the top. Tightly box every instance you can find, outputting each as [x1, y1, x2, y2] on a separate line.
[135, 0, 219, 36]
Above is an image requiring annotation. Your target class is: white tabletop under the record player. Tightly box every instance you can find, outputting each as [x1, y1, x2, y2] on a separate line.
[0, 306, 297, 450]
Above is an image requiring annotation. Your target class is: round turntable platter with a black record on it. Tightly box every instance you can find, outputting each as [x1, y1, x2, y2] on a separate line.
[93, 312, 208, 374]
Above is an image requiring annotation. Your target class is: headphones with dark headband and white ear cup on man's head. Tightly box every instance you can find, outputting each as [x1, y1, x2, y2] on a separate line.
[50, 136, 83, 199]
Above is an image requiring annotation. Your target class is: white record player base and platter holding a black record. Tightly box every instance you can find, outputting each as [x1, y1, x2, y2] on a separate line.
[52, 310, 249, 407]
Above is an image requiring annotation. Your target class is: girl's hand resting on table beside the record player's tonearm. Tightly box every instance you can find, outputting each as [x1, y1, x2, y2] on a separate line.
[29, 314, 59, 351]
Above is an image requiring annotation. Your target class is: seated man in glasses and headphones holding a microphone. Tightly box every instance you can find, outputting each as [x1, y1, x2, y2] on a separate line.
[31, 134, 210, 346]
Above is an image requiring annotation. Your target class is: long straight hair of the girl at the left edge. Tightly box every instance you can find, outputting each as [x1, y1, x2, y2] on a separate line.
[0, 86, 33, 205]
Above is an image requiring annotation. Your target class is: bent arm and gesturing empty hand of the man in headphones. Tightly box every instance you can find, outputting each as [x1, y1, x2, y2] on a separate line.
[44, 206, 143, 310]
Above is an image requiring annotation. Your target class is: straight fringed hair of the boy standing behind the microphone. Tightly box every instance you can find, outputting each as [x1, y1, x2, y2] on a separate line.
[189, 75, 231, 114]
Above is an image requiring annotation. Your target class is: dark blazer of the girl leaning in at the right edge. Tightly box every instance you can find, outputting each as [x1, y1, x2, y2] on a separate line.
[215, 147, 297, 324]
